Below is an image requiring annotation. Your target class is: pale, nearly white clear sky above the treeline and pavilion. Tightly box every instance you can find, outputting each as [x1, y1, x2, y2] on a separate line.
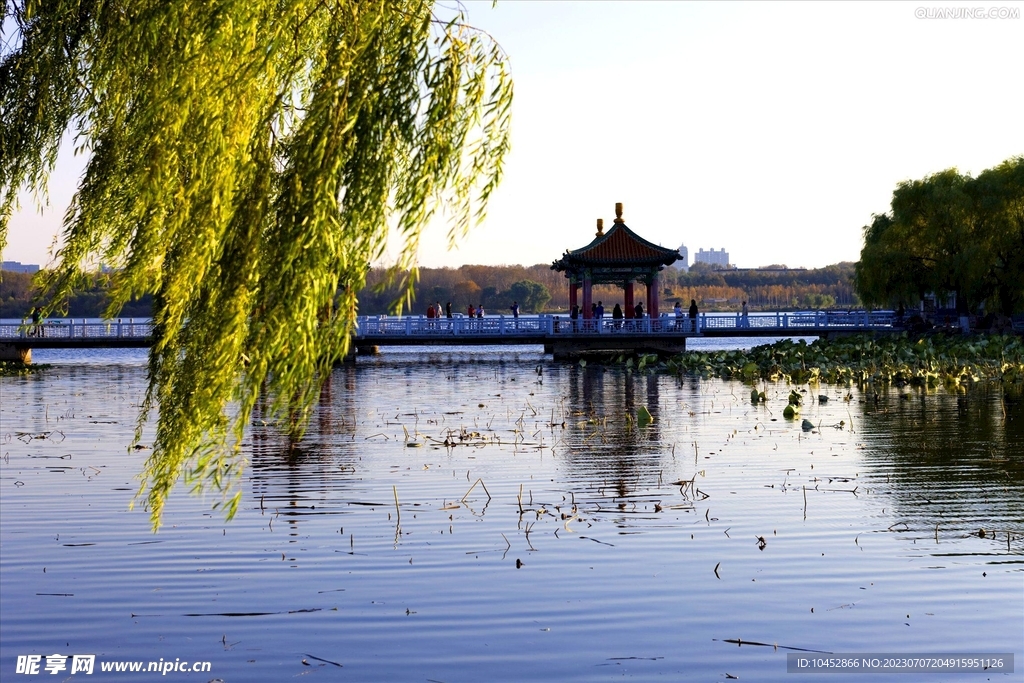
[3, 0, 1024, 267]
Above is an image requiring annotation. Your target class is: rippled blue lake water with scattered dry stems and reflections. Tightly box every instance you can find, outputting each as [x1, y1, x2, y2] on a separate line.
[0, 348, 1024, 683]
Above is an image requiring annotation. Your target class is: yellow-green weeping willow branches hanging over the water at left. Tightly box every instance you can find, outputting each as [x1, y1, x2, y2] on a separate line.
[0, 0, 512, 524]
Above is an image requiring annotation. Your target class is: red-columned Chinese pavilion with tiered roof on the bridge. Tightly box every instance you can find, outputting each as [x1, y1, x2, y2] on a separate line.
[551, 203, 682, 319]
